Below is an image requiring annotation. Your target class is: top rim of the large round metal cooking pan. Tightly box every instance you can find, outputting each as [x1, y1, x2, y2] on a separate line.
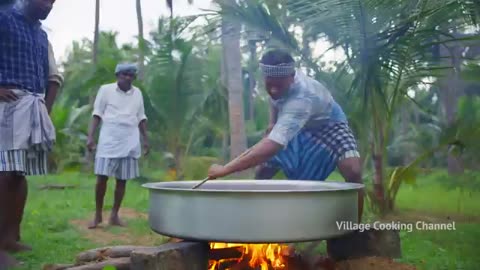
[142, 180, 365, 193]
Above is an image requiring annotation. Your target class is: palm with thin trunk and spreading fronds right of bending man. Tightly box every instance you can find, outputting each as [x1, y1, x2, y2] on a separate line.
[215, 0, 480, 213]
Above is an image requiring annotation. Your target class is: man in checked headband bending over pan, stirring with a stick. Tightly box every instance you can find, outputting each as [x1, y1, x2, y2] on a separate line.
[208, 50, 364, 218]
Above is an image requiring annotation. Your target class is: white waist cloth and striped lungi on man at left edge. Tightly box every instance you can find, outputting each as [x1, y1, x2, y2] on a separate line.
[0, 90, 55, 175]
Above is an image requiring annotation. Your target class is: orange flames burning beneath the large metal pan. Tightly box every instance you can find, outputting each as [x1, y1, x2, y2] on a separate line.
[209, 243, 288, 270]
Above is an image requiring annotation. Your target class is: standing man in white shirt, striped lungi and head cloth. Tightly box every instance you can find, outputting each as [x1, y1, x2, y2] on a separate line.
[87, 64, 149, 229]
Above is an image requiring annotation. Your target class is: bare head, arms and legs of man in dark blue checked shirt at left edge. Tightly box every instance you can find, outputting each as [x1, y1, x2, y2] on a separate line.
[0, 0, 59, 260]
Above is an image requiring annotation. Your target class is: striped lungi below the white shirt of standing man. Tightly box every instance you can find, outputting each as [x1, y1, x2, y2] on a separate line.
[94, 157, 140, 180]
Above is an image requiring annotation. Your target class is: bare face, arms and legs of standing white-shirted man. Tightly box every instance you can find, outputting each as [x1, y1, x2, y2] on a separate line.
[87, 72, 150, 229]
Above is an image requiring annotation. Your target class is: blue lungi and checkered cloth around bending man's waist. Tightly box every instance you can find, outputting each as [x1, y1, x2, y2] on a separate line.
[265, 122, 360, 181]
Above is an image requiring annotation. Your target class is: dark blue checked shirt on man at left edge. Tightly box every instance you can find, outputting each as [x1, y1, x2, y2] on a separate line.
[0, 8, 48, 94]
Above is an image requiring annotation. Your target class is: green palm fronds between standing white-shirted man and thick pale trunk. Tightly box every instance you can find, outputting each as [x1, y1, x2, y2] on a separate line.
[145, 16, 228, 177]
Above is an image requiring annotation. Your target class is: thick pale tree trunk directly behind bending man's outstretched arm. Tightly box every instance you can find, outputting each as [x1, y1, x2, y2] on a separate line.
[222, 15, 247, 175]
